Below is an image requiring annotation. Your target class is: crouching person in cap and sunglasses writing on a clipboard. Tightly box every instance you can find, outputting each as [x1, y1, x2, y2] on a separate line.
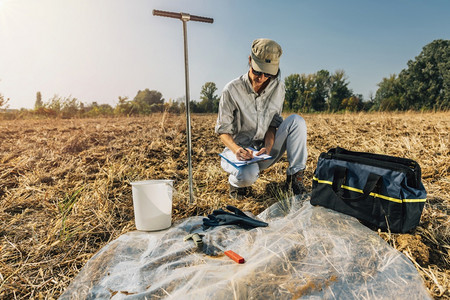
[215, 39, 308, 199]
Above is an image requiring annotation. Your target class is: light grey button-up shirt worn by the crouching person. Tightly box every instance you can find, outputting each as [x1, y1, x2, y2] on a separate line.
[215, 73, 285, 146]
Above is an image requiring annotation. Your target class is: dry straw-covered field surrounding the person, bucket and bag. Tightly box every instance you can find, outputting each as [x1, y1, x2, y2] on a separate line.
[0, 113, 450, 299]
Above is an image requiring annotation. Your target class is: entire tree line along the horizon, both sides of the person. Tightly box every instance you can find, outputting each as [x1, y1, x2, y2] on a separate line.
[0, 40, 450, 118]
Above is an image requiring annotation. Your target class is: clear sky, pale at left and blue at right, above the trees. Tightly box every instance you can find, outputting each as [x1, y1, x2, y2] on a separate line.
[0, 0, 450, 108]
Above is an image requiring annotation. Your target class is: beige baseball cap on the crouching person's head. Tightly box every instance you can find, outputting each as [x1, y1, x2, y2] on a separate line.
[251, 39, 283, 75]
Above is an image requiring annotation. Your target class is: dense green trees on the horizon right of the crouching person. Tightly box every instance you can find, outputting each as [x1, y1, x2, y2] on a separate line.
[285, 40, 450, 112]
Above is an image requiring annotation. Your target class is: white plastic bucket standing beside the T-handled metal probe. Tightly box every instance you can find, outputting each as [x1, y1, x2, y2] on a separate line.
[131, 180, 173, 231]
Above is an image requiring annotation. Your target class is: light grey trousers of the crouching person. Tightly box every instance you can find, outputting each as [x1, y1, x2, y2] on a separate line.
[221, 115, 308, 187]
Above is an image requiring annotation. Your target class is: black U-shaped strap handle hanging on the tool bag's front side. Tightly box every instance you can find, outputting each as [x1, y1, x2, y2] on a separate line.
[332, 166, 382, 201]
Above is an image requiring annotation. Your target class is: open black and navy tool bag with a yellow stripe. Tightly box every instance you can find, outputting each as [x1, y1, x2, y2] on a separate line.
[311, 148, 427, 233]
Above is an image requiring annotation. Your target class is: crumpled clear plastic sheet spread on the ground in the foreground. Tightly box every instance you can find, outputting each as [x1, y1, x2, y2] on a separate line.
[60, 195, 431, 300]
